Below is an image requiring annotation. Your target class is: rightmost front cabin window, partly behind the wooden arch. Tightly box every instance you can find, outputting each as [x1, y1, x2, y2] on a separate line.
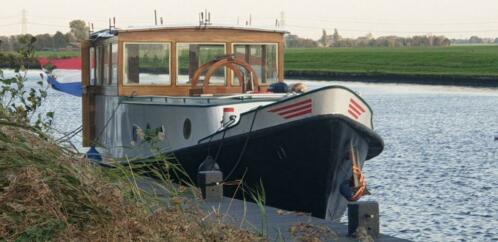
[233, 44, 278, 85]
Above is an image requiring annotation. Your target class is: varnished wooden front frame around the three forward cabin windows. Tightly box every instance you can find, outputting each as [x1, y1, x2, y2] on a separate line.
[114, 28, 284, 96]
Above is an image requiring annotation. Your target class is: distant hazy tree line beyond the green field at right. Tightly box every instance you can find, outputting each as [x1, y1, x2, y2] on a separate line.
[285, 29, 498, 48]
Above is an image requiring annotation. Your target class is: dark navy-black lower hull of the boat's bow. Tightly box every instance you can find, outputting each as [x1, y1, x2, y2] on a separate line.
[174, 115, 383, 219]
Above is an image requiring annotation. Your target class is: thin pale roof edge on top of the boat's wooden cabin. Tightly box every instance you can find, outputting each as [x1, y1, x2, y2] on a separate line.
[91, 25, 288, 39]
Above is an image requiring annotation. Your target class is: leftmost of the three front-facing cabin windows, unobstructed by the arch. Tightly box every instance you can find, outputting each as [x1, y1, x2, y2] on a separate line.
[124, 43, 171, 85]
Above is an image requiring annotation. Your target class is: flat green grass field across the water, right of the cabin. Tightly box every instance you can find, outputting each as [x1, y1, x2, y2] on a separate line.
[285, 46, 498, 77]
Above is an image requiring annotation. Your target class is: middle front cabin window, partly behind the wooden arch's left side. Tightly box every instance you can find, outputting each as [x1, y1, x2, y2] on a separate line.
[176, 43, 226, 86]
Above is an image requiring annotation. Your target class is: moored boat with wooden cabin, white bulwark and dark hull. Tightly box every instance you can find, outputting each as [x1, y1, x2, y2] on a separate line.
[76, 25, 383, 220]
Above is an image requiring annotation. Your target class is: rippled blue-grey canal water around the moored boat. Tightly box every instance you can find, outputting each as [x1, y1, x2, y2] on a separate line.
[2, 71, 498, 241]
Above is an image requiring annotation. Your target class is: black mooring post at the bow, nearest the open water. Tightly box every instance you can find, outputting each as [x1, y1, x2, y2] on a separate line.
[348, 201, 379, 238]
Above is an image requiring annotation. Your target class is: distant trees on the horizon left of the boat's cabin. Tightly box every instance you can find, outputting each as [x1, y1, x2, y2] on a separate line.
[0, 20, 90, 51]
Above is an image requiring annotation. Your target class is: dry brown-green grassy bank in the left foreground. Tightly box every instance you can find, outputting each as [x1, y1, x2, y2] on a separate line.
[0, 117, 263, 241]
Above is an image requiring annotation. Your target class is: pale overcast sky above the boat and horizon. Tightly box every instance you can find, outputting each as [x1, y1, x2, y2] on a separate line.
[0, 0, 498, 39]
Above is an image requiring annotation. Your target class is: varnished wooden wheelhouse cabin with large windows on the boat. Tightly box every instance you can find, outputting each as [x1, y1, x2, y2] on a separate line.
[81, 26, 285, 146]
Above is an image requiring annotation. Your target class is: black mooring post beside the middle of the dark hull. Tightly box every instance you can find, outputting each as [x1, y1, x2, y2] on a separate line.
[197, 170, 223, 202]
